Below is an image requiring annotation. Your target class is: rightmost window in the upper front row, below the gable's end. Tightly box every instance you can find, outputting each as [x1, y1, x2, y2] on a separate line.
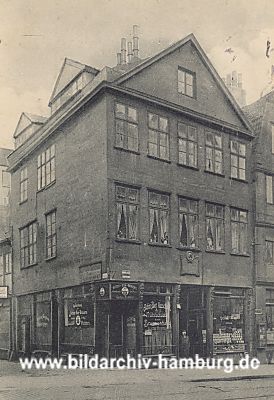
[230, 140, 246, 180]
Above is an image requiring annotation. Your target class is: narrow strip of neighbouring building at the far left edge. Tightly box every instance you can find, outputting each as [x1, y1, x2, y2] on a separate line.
[0, 148, 12, 358]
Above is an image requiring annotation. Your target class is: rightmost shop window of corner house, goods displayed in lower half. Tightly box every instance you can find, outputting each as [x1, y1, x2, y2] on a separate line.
[213, 289, 245, 354]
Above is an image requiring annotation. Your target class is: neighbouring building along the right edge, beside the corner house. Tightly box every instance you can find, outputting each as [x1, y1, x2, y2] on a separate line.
[243, 85, 274, 362]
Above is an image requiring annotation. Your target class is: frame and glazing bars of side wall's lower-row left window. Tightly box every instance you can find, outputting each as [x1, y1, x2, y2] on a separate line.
[19, 220, 38, 269]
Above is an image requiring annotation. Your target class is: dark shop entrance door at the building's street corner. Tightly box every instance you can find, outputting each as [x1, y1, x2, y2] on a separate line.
[109, 300, 137, 358]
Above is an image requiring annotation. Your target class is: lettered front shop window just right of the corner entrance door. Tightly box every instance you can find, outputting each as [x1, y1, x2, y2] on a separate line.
[143, 294, 173, 354]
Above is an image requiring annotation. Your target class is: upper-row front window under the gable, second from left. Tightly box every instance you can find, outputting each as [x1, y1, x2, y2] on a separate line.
[148, 113, 169, 160]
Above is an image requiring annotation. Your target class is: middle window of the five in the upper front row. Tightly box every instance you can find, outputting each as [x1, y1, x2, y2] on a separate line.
[178, 122, 197, 167]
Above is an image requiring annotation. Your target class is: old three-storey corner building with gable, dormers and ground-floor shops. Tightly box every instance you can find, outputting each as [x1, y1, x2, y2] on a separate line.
[9, 34, 254, 359]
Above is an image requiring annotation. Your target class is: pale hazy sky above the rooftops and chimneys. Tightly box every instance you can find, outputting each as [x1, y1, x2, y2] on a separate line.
[0, 0, 274, 148]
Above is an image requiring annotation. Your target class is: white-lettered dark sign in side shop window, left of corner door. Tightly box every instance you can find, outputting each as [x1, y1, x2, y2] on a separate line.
[65, 299, 94, 328]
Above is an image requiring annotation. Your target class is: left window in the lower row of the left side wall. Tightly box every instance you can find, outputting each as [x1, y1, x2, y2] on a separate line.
[20, 222, 37, 268]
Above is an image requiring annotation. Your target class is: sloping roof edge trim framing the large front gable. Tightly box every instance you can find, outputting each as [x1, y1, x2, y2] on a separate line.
[115, 33, 253, 135]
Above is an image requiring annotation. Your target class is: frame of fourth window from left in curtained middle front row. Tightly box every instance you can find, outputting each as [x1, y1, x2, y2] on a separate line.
[205, 201, 225, 253]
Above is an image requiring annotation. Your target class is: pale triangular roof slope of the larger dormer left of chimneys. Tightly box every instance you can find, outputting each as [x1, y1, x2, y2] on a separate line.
[49, 58, 100, 104]
